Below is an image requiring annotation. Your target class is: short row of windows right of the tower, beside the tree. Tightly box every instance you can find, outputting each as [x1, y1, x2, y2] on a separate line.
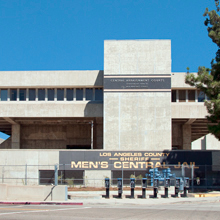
[171, 90, 208, 102]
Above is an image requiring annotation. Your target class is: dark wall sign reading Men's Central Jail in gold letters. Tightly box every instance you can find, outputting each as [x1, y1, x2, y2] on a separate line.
[59, 151, 217, 170]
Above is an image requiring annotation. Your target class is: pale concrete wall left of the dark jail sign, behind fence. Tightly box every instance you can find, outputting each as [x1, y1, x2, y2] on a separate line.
[0, 149, 59, 185]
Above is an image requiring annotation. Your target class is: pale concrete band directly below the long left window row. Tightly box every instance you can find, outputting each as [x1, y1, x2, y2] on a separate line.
[0, 101, 103, 117]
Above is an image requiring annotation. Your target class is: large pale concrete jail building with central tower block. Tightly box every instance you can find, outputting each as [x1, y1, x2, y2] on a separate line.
[0, 40, 220, 186]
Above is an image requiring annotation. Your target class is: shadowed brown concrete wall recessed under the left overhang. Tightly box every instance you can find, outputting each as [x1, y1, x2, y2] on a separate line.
[0, 118, 103, 149]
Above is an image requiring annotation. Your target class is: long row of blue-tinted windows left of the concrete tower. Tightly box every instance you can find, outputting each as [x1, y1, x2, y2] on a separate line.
[0, 88, 103, 101]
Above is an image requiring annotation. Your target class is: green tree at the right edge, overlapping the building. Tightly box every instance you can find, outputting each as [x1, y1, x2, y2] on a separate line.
[185, 0, 220, 140]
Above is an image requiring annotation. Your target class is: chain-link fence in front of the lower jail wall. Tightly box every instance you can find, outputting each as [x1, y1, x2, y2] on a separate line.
[0, 164, 220, 191]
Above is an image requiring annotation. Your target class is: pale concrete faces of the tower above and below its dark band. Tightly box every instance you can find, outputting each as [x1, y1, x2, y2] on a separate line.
[104, 40, 171, 150]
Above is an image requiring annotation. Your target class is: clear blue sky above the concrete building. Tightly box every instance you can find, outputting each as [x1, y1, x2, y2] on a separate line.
[0, 0, 217, 137]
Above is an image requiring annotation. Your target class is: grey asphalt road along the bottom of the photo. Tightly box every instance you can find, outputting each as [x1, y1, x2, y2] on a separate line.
[0, 200, 220, 220]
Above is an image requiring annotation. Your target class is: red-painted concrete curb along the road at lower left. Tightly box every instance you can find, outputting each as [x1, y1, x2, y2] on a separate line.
[0, 202, 83, 205]
